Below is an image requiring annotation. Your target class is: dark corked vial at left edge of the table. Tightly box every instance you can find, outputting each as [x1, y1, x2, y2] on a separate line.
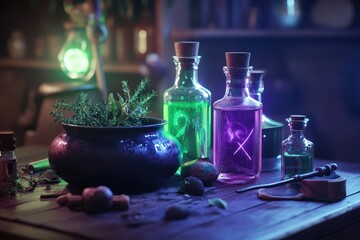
[0, 131, 17, 182]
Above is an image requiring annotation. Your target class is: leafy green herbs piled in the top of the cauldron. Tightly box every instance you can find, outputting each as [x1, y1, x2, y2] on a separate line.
[51, 78, 156, 127]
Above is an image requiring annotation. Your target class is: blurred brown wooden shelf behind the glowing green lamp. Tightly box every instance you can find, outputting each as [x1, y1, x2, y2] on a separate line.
[0, 58, 140, 74]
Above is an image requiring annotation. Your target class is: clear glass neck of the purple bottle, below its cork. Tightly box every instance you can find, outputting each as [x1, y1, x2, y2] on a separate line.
[223, 67, 252, 98]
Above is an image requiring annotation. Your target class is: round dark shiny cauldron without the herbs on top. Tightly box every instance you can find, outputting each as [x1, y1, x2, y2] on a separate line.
[49, 118, 181, 192]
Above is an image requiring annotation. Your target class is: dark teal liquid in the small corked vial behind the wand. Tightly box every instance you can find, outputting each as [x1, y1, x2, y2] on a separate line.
[282, 152, 312, 178]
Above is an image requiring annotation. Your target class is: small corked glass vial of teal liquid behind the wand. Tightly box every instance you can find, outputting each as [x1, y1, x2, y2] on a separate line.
[281, 115, 314, 179]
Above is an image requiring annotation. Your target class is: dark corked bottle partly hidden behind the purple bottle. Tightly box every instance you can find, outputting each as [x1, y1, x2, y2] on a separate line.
[249, 70, 284, 172]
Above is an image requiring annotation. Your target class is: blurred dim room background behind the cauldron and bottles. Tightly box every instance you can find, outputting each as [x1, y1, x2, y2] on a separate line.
[0, 0, 360, 162]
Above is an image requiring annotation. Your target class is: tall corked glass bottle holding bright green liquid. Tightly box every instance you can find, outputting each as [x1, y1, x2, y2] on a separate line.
[163, 42, 211, 167]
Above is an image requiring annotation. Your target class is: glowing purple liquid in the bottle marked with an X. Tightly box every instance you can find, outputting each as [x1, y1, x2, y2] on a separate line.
[213, 108, 262, 183]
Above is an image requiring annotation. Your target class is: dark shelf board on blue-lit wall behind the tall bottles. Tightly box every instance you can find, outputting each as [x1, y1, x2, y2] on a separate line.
[171, 28, 360, 40]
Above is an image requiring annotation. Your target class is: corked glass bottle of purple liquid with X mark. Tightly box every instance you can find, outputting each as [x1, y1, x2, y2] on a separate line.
[213, 52, 262, 183]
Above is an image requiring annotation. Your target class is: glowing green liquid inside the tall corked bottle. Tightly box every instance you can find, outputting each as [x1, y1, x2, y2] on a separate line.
[164, 101, 211, 162]
